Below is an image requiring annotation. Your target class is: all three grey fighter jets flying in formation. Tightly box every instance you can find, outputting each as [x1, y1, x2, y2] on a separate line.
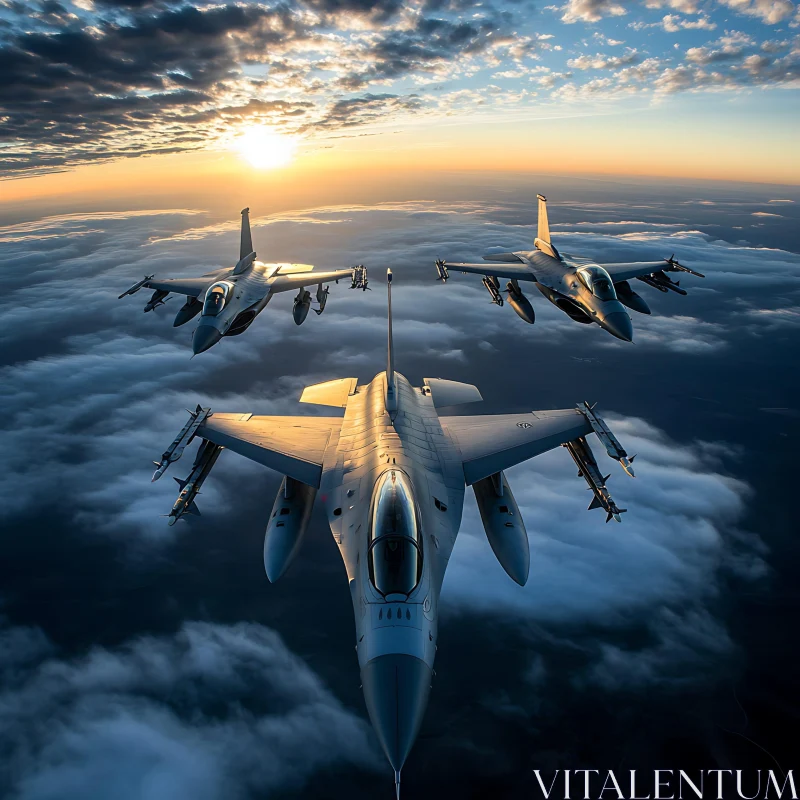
[122, 196, 698, 798]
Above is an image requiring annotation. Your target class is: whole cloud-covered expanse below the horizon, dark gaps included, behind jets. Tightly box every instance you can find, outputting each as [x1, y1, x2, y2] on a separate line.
[0, 189, 800, 800]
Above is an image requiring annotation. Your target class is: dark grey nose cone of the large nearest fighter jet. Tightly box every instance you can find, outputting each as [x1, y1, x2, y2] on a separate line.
[361, 653, 431, 773]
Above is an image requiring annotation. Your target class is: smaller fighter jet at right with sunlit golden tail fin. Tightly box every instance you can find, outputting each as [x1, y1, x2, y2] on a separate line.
[436, 195, 705, 342]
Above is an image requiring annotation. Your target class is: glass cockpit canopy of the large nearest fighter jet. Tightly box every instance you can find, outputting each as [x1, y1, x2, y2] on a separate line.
[367, 469, 422, 596]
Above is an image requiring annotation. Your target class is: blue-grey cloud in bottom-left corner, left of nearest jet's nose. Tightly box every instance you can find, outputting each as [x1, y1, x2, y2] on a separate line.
[0, 622, 380, 800]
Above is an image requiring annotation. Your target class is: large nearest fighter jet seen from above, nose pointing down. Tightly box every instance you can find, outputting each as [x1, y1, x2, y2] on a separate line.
[153, 271, 633, 798]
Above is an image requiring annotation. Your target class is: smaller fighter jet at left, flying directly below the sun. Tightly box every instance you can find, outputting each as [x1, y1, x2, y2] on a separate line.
[119, 208, 368, 355]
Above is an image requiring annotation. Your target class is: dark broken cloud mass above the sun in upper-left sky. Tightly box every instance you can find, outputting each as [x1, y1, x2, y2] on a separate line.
[0, 0, 524, 174]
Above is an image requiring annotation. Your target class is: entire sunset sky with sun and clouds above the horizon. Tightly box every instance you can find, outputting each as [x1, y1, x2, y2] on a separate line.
[0, 0, 800, 209]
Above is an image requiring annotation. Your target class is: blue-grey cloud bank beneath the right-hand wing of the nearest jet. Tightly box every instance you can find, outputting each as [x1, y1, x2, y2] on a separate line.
[443, 411, 766, 689]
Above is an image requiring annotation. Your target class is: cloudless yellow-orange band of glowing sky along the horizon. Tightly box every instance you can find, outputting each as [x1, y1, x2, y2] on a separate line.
[0, 112, 800, 217]
